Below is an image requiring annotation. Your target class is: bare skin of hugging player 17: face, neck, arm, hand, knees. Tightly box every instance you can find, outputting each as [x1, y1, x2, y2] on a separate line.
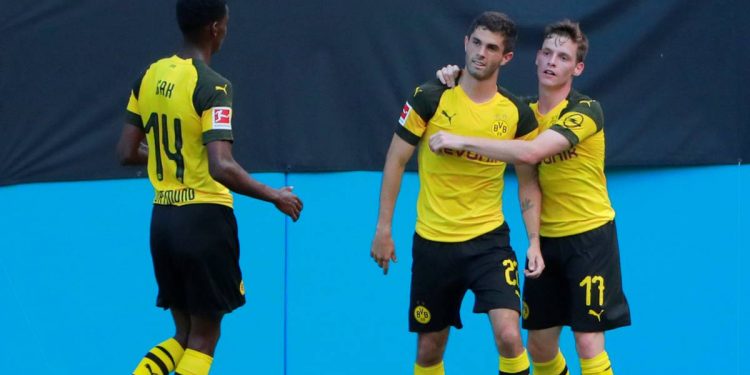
[430, 34, 604, 362]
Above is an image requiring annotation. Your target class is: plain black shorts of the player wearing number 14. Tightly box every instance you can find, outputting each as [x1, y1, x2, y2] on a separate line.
[151, 204, 245, 316]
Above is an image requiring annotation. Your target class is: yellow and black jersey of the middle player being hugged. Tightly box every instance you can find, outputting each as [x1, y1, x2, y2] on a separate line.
[396, 80, 537, 242]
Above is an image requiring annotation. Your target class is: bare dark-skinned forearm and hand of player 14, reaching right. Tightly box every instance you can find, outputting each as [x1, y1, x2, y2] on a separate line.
[206, 141, 302, 221]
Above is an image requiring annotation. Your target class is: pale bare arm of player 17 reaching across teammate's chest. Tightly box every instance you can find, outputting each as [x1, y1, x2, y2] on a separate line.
[430, 130, 572, 164]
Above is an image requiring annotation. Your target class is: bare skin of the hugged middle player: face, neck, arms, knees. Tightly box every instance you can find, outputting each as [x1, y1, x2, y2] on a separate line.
[370, 27, 544, 367]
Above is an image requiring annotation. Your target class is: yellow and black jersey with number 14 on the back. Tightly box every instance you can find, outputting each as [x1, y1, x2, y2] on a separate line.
[127, 56, 232, 207]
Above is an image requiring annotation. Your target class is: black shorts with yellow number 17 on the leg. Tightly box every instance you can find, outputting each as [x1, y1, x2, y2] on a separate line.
[523, 221, 630, 332]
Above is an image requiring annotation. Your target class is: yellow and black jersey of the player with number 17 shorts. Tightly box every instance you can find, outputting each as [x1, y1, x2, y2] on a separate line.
[530, 91, 615, 237]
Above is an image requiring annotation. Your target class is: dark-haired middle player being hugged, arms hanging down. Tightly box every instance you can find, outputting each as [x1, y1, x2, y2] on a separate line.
[370, 12, 544, 375]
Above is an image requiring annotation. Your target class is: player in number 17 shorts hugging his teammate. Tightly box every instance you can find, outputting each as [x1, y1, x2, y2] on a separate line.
[430, 20, 630, 375]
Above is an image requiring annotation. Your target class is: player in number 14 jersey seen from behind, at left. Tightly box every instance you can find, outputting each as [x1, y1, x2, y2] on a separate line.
[117, 0, 302, 375]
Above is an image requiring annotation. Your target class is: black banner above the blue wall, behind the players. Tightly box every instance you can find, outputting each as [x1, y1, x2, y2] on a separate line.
[0, 0, 750, 185]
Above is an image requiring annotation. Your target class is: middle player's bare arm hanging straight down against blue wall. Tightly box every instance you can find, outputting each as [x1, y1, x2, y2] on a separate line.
[370, 135, 416, 275]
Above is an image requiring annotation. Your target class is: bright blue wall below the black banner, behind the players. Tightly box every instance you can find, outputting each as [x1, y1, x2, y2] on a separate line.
[0, 166, 750, 375]
